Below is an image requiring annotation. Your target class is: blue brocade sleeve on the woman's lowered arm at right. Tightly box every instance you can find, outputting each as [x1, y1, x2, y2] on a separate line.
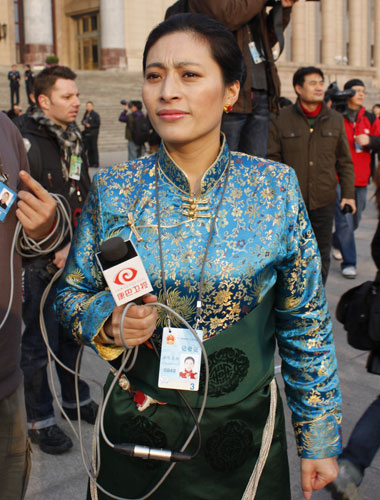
[275, 168, 341, 459]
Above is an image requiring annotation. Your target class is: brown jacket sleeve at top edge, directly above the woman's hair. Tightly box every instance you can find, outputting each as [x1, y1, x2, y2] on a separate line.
[189, 0, 267, 31]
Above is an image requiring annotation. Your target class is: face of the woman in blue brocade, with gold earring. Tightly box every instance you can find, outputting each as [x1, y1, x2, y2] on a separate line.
[142, 32, 239, 147]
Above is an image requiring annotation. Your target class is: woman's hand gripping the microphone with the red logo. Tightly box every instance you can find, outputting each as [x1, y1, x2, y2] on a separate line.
[104, 294, 158, 346]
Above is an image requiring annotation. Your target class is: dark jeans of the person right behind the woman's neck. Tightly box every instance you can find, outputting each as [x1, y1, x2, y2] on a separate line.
[222, 90, 269, 158]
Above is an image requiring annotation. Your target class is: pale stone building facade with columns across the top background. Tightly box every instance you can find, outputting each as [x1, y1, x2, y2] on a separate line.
[0, 0, 380, 95]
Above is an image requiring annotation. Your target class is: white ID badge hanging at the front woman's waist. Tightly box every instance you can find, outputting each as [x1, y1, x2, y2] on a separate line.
[158, 328, 203, 391]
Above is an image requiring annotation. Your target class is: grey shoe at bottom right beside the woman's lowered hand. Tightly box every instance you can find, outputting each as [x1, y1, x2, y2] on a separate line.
[326, 460, 363, 500]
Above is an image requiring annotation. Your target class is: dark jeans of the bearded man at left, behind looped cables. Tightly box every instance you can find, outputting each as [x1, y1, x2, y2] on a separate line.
[21, 260, 91, 429]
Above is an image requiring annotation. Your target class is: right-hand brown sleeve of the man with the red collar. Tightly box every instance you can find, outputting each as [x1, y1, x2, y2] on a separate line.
[335, 115, 355, 199]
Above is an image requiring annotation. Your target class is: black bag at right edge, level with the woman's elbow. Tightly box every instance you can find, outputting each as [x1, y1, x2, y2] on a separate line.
[336, 273, 380, 351]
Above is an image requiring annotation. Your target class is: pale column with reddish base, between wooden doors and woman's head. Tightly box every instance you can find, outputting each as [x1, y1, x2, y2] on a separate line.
[100, 0, 126, 69]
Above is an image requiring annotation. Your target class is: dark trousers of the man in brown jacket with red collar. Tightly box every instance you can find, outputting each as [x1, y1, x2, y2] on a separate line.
[308, 203, 335, 285]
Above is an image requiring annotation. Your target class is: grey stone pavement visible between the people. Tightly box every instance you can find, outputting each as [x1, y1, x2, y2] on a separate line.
[24, 151, 380, 500]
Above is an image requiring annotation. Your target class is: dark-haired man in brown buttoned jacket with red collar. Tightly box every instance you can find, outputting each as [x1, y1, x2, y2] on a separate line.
[267, 66, 356, 283]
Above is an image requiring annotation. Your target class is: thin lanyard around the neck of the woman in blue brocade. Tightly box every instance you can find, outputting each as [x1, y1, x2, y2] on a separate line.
[154, 155, 231, 330]
